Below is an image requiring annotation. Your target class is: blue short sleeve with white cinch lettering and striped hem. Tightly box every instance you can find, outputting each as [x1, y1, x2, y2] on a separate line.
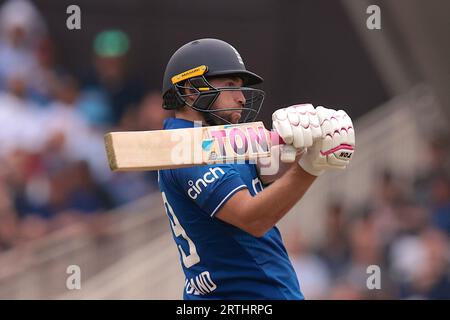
[173, 164, 247, 217]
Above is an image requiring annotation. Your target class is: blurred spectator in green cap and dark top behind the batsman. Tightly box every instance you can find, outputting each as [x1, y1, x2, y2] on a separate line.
[80, 30, 144, 126]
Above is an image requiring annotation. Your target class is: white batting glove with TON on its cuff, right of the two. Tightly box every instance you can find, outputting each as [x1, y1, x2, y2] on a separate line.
[299, 107, 355, 176]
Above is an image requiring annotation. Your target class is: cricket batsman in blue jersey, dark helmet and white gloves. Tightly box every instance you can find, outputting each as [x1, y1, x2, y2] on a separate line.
[158, 39, 355, 300]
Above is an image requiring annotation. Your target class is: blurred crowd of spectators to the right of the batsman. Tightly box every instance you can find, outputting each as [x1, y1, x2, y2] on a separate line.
[286, 137, 450, 299]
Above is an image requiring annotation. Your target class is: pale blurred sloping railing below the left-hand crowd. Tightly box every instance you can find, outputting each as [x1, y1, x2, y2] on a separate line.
[0, 193, 178, 299]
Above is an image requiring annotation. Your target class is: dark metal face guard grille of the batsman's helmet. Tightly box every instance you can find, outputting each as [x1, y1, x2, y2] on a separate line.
[174, 69, 265, 125]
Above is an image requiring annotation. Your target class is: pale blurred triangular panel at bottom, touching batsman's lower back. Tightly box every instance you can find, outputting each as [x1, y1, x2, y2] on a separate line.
[58, 230, 183, 299]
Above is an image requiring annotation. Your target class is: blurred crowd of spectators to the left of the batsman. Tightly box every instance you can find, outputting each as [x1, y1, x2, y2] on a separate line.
[0, 0, 172, 252]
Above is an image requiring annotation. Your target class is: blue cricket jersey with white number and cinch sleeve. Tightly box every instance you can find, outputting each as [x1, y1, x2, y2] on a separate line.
[158, 118, 303, 300]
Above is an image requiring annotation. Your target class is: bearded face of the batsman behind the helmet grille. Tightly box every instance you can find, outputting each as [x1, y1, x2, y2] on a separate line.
[209, 77, 245, 123]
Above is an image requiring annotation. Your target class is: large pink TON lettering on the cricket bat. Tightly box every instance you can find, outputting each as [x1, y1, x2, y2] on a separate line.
[210, 126, 269, 158]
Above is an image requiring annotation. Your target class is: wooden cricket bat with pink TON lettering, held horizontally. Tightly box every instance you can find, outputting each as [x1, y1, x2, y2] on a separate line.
[104, 122, 296, 171]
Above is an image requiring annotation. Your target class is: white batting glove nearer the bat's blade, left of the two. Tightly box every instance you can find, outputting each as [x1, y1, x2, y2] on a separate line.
[272, 104, 322, 162]
